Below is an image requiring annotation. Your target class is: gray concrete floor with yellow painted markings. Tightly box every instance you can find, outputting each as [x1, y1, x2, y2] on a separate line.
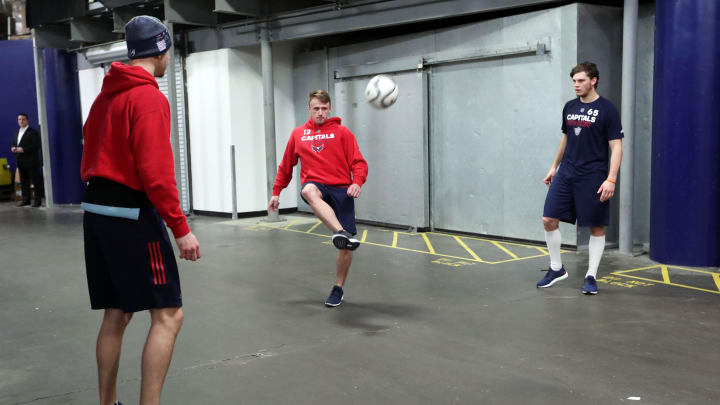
[0, 203, 720, 405]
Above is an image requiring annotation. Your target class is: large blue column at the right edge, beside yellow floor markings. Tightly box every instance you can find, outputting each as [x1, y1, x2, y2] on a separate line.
[650, 0, 720, 266]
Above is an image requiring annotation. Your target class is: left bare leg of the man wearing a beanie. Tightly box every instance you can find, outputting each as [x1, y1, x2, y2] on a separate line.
[95, 309, 132, 405]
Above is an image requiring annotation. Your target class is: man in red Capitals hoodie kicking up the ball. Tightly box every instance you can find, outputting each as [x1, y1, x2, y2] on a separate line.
[268, 90, 368, 307]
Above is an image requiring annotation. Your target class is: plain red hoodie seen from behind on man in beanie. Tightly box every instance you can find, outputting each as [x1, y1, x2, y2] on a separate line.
[80, 62, 190, 238]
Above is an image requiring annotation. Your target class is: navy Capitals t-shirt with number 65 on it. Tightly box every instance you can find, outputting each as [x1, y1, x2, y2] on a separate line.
[560, 97, 624, 176]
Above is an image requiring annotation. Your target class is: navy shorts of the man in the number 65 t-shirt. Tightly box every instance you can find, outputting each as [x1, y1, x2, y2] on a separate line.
[543, 169, 610, 226]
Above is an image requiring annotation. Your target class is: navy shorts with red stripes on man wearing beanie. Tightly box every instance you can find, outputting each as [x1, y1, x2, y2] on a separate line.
[83, 207, 182, 312]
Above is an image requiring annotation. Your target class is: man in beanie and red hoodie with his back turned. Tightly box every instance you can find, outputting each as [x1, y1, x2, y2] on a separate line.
[81, 16, 200, 405]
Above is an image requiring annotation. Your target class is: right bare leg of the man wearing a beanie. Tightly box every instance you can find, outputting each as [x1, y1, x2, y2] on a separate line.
[140, 308, 183, 405]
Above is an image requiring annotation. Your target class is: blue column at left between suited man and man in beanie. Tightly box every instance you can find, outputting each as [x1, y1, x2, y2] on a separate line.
[43, 49, 85, 204]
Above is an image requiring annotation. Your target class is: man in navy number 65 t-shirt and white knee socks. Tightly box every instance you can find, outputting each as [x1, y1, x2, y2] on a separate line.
[537, 62, 623, 294]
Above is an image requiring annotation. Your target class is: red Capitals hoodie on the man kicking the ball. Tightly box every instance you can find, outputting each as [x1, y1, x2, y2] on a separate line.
[273, 117, 368, 195]
